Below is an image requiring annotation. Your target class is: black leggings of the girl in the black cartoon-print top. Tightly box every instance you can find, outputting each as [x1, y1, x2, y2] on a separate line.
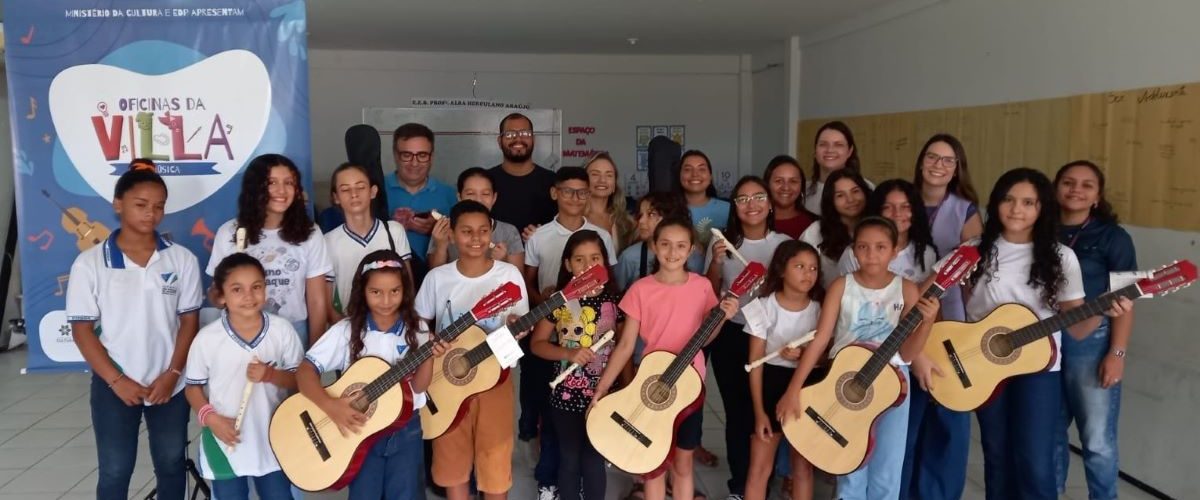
[546, 406, 606, 500]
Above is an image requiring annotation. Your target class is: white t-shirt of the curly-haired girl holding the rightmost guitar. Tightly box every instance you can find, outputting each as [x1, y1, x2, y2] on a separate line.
[955, 236, 1084, 372]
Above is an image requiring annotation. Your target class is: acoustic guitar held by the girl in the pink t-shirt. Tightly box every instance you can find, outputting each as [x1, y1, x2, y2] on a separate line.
[587, 261, 767, 475]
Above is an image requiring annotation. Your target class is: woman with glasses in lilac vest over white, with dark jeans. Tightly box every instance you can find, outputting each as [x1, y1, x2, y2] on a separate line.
[901, 133, 983, 499]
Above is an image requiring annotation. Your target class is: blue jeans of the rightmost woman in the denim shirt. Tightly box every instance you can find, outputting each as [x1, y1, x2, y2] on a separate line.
[1055, 318, 1121, 500]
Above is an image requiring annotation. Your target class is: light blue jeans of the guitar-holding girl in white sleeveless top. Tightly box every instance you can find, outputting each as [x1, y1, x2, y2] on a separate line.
[838, 367, 911, 500]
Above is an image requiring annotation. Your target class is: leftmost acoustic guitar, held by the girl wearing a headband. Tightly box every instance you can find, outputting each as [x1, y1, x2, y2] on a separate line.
[269, 282, 521, 492]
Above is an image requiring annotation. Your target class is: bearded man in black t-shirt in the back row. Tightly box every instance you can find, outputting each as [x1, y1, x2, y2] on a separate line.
[487, 113, 558, 240]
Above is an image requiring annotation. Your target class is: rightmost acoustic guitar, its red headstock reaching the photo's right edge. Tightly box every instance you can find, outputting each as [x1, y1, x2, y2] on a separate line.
[924, 260, 1196, 411]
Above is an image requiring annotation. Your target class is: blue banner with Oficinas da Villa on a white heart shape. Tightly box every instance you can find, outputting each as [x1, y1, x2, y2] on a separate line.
[4, 0, 312, 372]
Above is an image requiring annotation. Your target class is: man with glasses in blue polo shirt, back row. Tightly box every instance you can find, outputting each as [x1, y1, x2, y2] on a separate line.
[386, 124, 457, 259]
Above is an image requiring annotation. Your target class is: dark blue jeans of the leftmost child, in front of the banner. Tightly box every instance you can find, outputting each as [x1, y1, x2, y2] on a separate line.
[91, 374, 188, 500]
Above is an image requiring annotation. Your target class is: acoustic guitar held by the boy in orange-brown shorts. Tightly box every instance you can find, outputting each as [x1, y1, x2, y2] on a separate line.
[421, 265, 608, 439]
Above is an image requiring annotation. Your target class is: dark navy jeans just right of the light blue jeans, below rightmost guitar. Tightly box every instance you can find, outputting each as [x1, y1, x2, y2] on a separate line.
[900, 384, 971, 500]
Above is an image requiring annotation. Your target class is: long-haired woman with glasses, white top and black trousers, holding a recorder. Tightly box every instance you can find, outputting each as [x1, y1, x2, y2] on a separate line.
[704, 175, 790, 499]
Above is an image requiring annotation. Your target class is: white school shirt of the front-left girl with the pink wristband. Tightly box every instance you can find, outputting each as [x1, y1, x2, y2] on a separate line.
[184, 313, 304, 480]
